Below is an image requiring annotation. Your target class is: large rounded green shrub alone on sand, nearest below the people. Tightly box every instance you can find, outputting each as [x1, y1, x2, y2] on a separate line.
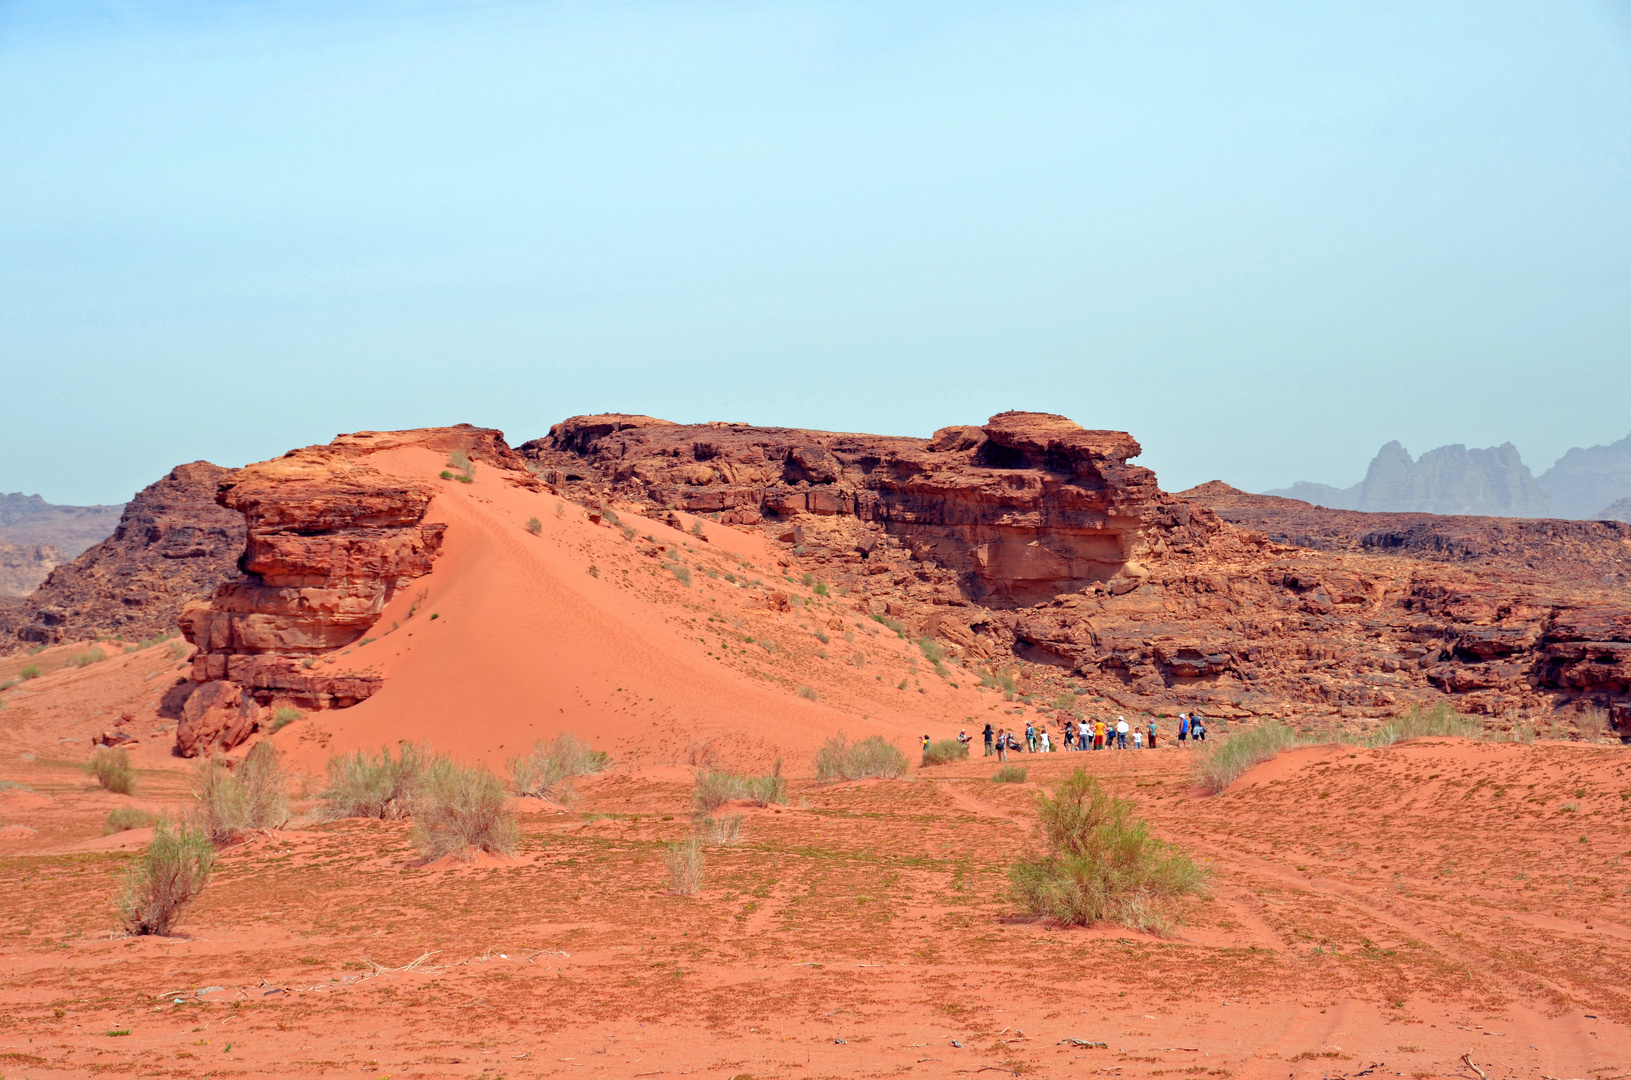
[1008, 768, 1205, 930]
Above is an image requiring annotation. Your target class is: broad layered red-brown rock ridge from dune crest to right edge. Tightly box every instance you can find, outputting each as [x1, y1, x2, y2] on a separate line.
[538, 413, 1631, 729]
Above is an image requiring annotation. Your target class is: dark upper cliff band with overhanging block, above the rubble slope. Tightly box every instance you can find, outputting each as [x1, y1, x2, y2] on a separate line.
[520, 413, 1218, 607]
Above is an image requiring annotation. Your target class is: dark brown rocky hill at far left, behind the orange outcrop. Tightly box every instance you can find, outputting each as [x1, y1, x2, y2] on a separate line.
[0, 462, 245, 648]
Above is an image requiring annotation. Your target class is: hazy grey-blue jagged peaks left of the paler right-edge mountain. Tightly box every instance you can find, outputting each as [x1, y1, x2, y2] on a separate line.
[1267, 442, 1551, 517]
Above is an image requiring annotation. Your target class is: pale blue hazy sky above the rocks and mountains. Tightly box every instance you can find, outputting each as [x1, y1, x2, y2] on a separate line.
[0, 0, 1631, 502]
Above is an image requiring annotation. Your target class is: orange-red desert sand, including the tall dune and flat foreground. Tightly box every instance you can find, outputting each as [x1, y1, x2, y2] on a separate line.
[0, 450, 1631, 1080]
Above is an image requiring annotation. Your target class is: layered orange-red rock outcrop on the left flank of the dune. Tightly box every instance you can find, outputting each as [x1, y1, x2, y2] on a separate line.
[176, 424, 521, 755]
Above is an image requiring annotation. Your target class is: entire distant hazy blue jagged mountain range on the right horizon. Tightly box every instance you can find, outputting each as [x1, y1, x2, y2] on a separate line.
[1264, 436, 1631, 520]
